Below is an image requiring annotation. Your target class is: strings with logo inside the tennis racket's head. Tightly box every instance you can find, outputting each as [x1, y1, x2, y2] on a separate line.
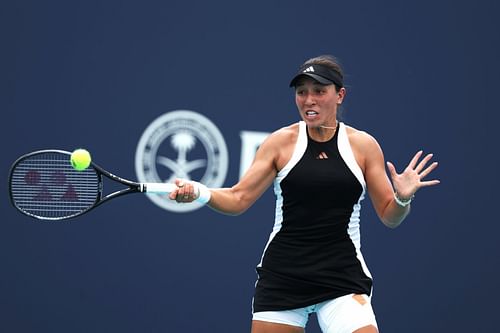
[11, 152, 99, 219]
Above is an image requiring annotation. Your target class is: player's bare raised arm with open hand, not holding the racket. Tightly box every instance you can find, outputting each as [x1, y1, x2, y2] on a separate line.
[362, 134, 439, 228]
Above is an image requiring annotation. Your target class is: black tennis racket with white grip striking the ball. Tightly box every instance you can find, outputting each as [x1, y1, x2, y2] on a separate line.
[9, 150, 176, 220]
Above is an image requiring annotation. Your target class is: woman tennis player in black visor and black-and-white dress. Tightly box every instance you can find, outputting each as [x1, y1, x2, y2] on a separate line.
[170, 56, 439, 333]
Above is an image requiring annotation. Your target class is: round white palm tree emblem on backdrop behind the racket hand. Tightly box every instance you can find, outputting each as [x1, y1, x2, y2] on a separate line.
[135, 110, 229, 212]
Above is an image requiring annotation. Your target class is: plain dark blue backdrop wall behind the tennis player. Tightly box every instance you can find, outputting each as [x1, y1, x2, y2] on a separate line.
[0, 0, 500, 332]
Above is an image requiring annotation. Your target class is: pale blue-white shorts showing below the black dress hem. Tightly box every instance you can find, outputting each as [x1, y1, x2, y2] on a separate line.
[253, 294, 378, 333]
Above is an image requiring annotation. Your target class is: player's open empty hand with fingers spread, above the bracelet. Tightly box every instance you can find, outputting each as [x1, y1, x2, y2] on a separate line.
[387, 151, 440, 200]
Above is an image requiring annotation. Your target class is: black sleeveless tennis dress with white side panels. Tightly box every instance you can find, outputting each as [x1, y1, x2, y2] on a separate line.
[253, 122, 372, 312]
